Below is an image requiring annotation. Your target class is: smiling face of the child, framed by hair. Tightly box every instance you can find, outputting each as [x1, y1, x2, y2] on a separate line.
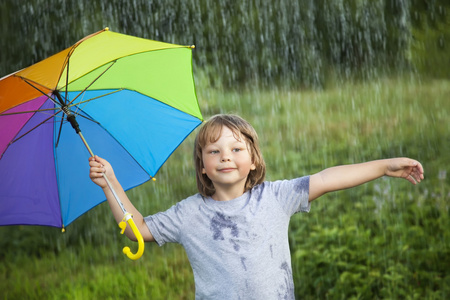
[202, 126, 255, 198]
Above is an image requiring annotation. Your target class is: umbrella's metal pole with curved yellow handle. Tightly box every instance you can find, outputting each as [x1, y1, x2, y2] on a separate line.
[63, 107, 144, 260]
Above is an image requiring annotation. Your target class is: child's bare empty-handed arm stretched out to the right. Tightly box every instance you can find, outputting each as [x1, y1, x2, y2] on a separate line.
[309, 158, 424, 201]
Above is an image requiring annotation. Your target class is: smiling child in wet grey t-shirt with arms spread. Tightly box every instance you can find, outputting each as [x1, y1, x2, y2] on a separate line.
[90, 115, 424, 299]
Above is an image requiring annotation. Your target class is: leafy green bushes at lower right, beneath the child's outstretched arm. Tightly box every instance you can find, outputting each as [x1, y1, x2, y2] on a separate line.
[291, 179, 450, 299]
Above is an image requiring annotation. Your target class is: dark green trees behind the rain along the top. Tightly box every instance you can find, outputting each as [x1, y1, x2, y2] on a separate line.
[0, 0, 450, 88]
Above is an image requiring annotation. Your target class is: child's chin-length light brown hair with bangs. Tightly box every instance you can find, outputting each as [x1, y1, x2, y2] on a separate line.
[194, 114, 266, 196]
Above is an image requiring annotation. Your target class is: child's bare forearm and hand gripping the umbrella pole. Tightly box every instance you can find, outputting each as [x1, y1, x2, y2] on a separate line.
[89, 155, 155, 242]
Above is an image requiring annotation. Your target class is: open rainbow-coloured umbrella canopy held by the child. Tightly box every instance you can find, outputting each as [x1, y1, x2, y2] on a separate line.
[0, 28, 203, 258]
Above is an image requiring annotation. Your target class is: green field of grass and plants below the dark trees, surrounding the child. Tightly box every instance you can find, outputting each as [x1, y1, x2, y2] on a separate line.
[0, 78, 450, 299]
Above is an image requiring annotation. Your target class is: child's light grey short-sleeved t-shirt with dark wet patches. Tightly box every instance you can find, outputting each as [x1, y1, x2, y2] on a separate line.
[145, 176, 310, 300]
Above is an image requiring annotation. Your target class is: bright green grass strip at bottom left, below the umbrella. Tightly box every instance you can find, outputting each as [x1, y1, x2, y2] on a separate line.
[0, 246, 194, 300]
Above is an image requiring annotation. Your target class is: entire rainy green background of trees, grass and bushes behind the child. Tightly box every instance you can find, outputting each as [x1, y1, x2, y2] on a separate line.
[0, 0, 450, 299]
